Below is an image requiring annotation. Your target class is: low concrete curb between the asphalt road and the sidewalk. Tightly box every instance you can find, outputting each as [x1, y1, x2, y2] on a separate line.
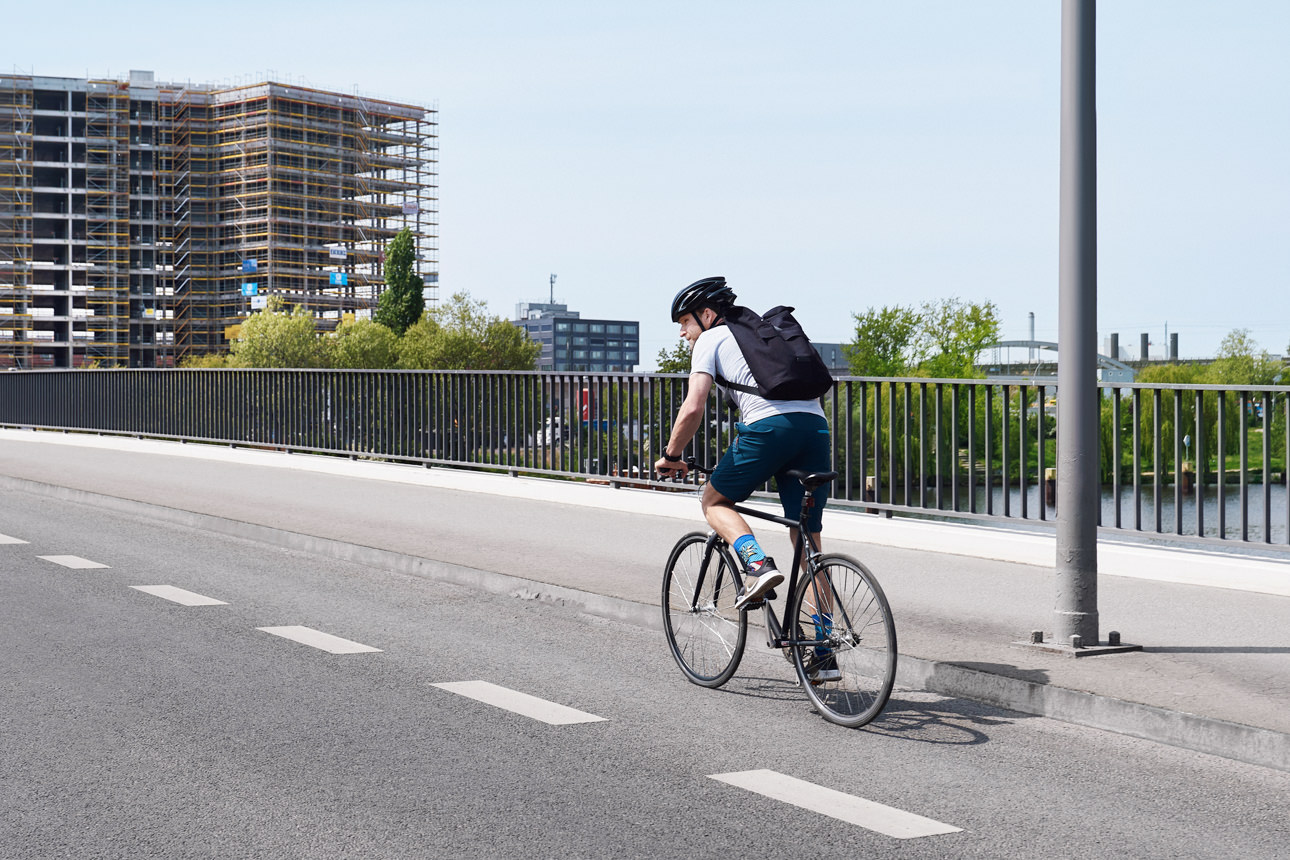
[0, 476, 1290, 772]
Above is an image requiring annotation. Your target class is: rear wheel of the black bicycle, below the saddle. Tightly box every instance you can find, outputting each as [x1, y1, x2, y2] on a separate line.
[789, 556, 897, 728]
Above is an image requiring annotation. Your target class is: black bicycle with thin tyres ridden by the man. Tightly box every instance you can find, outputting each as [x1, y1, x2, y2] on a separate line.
[663, 456, 897, 728]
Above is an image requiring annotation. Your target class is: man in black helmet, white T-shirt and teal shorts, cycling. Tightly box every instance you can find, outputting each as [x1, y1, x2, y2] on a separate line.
[654, 277, 832, 609]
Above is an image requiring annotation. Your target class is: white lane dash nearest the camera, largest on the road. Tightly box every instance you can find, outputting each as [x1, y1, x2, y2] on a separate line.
[711, 770, 961, 839]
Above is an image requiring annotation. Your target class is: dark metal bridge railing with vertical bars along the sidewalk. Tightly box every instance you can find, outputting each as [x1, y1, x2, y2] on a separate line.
[0, 370, 1290, 549]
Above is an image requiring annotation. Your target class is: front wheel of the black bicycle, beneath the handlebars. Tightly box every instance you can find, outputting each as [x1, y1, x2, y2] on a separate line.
[663, 531, 748, 687]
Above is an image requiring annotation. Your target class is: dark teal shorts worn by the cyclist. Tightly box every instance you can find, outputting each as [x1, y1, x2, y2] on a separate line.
[710, 413, 832, 531]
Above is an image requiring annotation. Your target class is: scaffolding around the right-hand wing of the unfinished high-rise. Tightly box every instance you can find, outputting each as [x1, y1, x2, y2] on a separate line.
[174, 83, 437, 358]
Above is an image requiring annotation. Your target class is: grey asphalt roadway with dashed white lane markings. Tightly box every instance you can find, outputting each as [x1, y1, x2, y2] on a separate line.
[0, 491, 1290, 859]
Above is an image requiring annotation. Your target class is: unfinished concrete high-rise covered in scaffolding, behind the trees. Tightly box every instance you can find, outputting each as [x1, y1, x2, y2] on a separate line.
[0, 72, 439, 367]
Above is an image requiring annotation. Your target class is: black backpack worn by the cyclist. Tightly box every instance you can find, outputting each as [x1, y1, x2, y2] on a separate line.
[716, 304, 833, 400]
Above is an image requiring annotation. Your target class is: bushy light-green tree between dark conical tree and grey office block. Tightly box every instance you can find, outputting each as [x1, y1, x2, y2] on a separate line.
[399, 293, 542, 370]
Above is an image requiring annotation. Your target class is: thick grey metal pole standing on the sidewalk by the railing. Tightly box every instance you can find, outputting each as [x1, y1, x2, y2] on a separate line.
[1054, 0, 1100, 645]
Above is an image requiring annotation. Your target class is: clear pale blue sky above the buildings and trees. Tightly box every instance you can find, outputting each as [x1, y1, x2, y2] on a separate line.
[5, 0, 1290, 369]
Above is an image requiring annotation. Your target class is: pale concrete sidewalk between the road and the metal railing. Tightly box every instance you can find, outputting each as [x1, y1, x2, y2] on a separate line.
[0, 431, 1290, 771]
